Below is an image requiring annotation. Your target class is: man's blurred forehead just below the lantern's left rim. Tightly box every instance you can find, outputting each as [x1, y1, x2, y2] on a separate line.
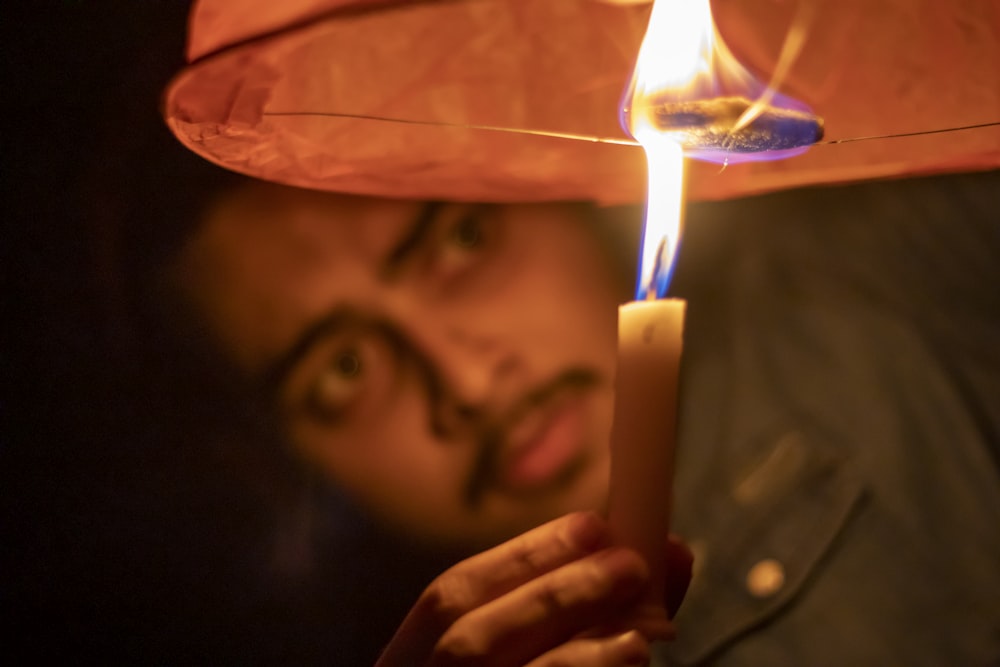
[186, 183, 422, 376]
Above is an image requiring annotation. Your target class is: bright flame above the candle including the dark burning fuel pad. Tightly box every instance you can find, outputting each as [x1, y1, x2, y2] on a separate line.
[622, 0, 823, 299]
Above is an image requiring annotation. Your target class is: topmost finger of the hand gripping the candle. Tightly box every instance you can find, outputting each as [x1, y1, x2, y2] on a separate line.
[378, 512, 610, 666]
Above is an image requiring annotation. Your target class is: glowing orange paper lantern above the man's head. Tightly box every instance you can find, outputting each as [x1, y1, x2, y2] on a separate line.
[164, 0, 1000, 203]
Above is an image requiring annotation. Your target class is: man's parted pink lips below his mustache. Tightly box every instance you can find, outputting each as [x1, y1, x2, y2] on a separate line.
[495, 391, 586, 491]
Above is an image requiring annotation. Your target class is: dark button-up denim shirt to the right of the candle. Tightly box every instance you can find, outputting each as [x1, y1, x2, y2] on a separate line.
[657, 172, 1000, 666]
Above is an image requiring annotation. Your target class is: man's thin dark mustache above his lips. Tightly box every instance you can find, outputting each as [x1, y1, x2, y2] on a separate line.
[462, 368, 600, 509]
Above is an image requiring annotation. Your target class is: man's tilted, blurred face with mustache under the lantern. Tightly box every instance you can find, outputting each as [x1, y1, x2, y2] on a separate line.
[187, 185, 623, 546]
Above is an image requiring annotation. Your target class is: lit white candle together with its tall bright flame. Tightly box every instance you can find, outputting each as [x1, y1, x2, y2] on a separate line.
[608, 0, 692, 617]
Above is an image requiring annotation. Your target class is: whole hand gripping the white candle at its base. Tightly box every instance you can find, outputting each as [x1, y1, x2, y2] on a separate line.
[378, 513, 690, 667]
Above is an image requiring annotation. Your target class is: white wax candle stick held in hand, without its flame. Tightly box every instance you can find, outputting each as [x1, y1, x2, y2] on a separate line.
[608, 299, 687, 607]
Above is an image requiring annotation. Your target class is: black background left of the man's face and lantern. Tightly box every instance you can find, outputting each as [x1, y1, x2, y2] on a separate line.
[0, 0, 438, 664]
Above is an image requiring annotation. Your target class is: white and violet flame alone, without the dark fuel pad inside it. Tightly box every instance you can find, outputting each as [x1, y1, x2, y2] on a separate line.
[622, 0, 821, 299]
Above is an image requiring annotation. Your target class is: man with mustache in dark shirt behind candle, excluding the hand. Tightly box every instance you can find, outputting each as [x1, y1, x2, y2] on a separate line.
[172, 174, 1000, 665]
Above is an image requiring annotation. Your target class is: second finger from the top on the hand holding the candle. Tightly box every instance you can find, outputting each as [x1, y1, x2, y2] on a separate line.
[430, 547, 649, 666]
